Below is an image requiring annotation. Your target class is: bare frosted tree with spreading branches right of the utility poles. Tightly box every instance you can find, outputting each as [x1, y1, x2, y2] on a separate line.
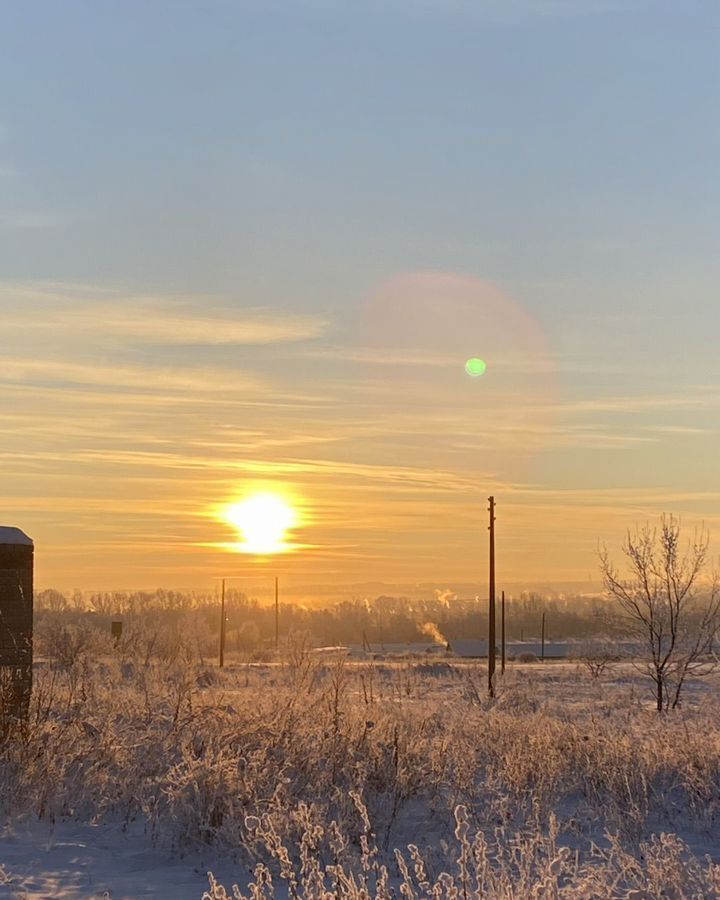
[600, 516, 720, 712]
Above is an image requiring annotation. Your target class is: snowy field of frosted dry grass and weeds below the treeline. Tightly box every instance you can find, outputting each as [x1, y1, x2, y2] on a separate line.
[0, 649, 720, 900]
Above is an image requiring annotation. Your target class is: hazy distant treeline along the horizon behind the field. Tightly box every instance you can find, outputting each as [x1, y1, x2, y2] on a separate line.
[35, 589, 607, 651]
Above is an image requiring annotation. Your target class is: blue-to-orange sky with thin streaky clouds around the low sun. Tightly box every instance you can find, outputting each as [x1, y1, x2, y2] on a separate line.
[0, 0, 720, 590]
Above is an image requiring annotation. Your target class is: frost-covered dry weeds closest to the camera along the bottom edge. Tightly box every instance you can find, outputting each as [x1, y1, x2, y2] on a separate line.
[203, 795, 720, 900]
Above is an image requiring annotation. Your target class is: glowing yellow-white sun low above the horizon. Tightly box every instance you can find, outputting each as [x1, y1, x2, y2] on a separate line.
[224, 493, 298, 556]
